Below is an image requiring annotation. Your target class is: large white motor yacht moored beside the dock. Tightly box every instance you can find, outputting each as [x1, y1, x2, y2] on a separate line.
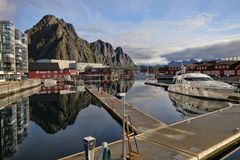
[168, 73, 236, 100]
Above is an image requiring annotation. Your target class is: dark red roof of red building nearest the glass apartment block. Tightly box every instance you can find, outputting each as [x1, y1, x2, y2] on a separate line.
[29, 63, 60, 71]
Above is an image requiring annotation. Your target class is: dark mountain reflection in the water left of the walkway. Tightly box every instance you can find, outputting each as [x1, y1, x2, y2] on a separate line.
[30, 91, 96, 134]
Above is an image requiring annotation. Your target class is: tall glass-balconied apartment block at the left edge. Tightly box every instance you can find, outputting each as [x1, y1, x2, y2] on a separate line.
[0, 20, 28, 81]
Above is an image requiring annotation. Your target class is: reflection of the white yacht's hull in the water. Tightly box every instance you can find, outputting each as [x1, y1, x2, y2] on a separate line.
[169, 92, 231, 117]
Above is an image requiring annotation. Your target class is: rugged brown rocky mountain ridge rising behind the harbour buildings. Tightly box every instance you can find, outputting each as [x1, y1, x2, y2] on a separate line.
[26, 15, 135, 68]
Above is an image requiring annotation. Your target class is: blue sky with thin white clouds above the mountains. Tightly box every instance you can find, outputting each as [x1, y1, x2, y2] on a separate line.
[0, 0, 240, 64]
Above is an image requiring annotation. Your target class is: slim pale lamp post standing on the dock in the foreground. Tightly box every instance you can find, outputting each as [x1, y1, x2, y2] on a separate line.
[118, 93, 126, 160]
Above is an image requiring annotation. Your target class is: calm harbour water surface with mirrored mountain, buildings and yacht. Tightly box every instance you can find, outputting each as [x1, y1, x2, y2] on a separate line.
[0, 80, 232, 160]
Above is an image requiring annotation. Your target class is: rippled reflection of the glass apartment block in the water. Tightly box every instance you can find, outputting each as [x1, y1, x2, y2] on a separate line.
[0, 98, 29, 159]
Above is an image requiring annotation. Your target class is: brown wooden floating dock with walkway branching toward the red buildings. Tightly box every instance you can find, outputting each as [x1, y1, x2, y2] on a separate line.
[62, 86, 240, 160]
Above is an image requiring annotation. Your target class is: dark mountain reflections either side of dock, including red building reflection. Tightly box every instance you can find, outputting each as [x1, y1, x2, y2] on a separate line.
[30, 81, 134, 134]
